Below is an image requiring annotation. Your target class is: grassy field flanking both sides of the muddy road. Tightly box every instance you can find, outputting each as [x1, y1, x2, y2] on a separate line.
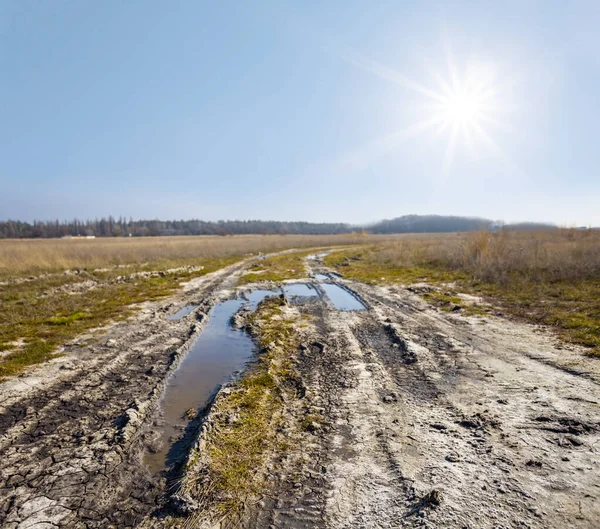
[0, 230, 600, 377]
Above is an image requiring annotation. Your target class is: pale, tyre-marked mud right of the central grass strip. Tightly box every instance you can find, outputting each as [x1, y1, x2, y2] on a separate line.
[239, 262, 600, 529]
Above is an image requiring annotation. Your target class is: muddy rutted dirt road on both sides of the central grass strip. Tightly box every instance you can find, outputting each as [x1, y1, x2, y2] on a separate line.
[0, 250, 600, 529]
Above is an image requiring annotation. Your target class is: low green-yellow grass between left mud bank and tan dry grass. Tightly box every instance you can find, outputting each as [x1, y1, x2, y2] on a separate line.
[0, 257, 241, 380]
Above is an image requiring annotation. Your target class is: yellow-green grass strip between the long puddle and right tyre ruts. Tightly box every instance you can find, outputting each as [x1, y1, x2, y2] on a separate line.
[184, 298, 298, 527]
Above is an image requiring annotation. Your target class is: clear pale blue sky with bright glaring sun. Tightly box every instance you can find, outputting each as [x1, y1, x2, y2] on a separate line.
[0, 0, 600, 225]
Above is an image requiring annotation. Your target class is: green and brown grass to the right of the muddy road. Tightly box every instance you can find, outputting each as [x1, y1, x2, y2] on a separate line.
[325, 230, 600, 356]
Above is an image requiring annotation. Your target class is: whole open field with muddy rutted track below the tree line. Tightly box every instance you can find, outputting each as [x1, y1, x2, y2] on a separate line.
[0, 230, 600, 529]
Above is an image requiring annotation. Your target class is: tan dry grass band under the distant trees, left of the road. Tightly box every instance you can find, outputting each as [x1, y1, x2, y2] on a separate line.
[0, 235, 372, 279]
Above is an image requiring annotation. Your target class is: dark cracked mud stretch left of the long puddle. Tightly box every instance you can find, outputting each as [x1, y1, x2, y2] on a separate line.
[0, 256, 251, 529]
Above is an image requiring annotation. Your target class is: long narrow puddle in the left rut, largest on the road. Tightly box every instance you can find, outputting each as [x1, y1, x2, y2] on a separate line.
[144, 290, 276, 473]
